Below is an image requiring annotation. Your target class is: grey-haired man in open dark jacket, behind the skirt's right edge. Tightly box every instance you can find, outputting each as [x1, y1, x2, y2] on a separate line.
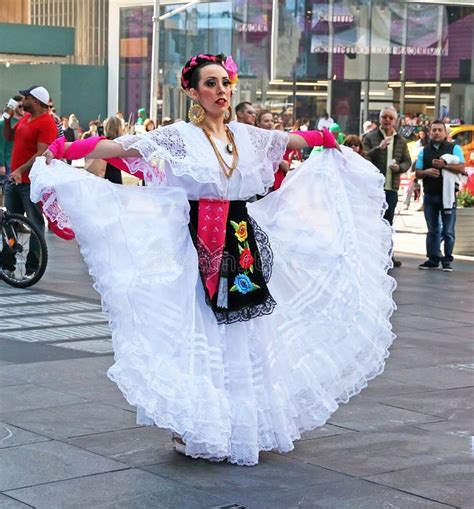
[362, 106, 411, 267]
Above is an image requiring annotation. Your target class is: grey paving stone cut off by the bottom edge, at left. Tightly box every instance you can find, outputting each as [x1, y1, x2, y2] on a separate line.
[4, 470, 231, 509]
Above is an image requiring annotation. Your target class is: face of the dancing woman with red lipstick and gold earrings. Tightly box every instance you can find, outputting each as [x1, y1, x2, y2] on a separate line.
[189, 64, 232, 116]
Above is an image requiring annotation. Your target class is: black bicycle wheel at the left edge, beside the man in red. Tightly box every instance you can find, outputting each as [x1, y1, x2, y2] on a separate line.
[0, 212, 48, 288]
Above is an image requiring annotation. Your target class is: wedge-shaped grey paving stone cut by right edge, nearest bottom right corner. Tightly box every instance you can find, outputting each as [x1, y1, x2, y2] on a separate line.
[367, 457, 474, 507]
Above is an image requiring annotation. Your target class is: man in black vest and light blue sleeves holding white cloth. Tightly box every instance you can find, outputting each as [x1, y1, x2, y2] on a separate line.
[416, 120, 465, 272]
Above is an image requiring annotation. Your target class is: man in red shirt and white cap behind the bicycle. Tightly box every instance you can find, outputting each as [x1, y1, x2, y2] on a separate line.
[2, 86, 57, 276]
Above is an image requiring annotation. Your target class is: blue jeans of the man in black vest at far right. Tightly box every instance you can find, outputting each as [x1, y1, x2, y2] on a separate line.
[423, 190, 456, 263]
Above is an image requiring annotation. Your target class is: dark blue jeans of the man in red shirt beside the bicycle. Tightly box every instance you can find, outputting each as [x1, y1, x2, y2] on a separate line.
[2, 181, 45, 273]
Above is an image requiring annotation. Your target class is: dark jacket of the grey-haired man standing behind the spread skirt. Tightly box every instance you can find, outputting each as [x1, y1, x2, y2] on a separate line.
[362, 129, 411, 191]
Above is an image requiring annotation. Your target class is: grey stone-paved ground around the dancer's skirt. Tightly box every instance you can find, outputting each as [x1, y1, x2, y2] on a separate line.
[0, 234, 474, 509]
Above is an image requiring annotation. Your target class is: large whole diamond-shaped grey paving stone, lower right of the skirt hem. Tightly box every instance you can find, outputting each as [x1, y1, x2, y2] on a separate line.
[290, 426, 470, 477]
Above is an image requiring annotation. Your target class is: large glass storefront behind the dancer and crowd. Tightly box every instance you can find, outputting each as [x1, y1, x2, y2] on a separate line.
[118, 0, 474, 132]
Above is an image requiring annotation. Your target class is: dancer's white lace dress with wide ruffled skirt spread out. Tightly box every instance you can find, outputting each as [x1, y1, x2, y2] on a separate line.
[31, 122, 395, 465]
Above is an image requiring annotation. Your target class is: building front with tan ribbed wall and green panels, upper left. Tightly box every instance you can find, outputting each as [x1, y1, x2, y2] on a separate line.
[0, 0, 109, 123]
